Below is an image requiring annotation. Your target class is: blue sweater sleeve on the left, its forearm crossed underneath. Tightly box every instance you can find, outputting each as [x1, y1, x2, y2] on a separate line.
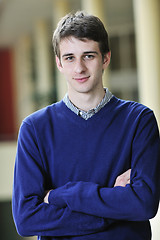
[12, 122, 106, 236]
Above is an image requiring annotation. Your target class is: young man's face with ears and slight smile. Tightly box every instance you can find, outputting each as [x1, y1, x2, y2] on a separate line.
[56, 37, 110, 96]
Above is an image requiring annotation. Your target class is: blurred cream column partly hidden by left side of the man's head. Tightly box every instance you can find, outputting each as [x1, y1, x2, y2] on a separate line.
[53, 0, 70, 100]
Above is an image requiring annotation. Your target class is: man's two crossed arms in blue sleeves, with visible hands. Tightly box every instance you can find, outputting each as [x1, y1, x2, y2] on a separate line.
[12, 110, 160, 236]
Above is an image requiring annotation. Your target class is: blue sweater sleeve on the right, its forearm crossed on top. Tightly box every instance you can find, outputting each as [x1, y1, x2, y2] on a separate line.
[49, 111, 160, 221]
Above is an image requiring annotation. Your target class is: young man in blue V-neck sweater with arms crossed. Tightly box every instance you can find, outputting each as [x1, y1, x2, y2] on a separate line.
[13, 12, 160, 240]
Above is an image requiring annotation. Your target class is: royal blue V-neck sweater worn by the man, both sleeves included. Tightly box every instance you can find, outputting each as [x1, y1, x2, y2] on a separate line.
[12, 97, 160, 240]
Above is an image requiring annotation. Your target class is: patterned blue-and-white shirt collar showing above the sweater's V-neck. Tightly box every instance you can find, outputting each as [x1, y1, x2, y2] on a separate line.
[63, 88, 113, 120]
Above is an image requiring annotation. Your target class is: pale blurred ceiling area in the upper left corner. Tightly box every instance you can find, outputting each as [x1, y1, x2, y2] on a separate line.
[0, 0, 53, 47]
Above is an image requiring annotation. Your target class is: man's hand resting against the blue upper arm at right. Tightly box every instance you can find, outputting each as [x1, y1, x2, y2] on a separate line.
[114, 169, 131, 187]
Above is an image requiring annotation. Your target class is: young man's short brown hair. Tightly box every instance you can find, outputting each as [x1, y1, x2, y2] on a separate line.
[52, 11, 109, 58]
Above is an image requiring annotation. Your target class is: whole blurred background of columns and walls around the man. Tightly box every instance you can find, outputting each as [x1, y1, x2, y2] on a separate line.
[0, 0, 160, 240]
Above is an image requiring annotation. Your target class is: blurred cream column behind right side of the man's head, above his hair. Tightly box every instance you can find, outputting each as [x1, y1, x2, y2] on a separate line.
[81, 0, 109, 87]
